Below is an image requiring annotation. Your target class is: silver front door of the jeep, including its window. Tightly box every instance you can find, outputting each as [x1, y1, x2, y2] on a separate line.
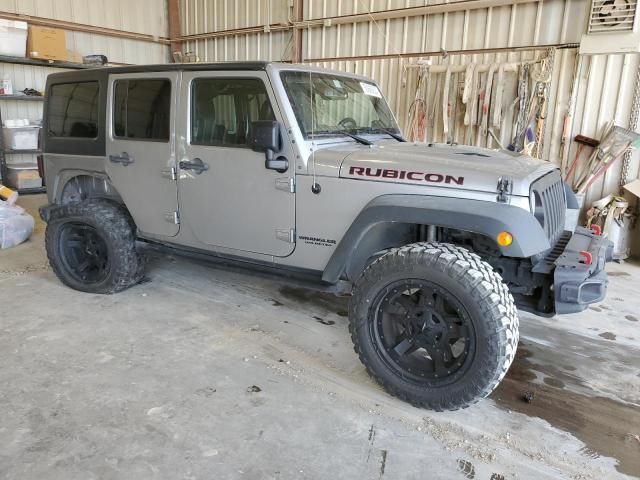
[178, 72, 295, 257]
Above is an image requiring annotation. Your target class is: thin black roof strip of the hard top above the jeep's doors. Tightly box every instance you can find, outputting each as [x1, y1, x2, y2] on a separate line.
[49, 62, 276, 82]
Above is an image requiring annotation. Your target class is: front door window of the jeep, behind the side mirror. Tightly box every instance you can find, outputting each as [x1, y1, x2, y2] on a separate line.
[191, 78, 275, 147]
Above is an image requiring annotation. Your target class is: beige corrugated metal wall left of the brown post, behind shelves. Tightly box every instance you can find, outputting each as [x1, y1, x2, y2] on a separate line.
[0, 0, 169, 167]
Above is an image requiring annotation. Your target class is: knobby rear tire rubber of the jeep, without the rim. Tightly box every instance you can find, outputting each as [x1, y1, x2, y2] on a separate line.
[45, 199, 144, 294]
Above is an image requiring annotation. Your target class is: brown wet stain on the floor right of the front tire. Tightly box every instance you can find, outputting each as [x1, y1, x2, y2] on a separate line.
[491, 344, 640, 476]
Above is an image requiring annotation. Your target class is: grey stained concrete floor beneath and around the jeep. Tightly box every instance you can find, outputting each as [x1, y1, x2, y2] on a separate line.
[0, 196, 640, 480]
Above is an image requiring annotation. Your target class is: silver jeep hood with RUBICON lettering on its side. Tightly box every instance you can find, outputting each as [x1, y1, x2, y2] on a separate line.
[328, 142, 557, 196]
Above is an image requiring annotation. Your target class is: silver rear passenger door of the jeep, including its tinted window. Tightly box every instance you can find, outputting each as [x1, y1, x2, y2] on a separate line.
[106, 72, 180, 237]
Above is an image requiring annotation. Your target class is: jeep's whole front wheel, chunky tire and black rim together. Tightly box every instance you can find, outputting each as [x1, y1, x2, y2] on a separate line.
[349, 243, 518, 411]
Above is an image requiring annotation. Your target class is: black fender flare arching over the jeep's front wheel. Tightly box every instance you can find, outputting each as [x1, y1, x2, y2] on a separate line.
[322, 195, 551, 283]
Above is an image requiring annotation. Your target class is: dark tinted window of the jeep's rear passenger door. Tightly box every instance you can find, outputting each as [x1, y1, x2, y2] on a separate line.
[113, 79, 171, 142]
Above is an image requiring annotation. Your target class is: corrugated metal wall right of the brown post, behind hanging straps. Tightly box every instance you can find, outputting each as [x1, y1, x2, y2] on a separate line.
[180, 0, 640, 253]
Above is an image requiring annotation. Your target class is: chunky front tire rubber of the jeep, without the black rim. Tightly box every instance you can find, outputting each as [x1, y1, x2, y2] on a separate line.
[349, 243, 519, 411]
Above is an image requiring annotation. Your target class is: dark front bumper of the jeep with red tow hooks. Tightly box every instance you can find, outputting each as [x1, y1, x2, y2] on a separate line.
[553, 227, 613, 315]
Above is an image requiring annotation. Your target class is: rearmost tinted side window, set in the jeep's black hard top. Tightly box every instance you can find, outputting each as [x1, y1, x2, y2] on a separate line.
[47, 82, 100, 138]
